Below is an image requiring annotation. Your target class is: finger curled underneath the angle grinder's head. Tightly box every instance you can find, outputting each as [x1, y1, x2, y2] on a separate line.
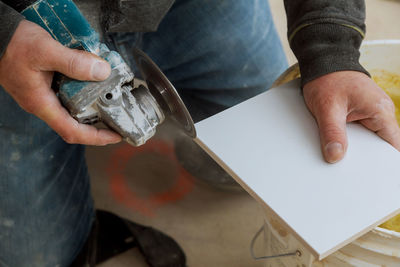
[33, 90, 121, 145]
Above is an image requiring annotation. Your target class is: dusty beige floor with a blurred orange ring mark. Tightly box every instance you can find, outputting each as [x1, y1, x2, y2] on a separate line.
[87, 0, 400, 267]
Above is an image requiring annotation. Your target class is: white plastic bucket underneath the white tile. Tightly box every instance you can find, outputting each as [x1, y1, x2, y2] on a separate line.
[264, 40, 400, 267]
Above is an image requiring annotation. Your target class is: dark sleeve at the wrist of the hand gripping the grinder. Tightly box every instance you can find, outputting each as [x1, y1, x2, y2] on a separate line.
[0, 1, 24, 58]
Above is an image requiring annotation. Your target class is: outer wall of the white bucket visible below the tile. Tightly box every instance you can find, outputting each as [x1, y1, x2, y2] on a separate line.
[264, 210, 400, 267]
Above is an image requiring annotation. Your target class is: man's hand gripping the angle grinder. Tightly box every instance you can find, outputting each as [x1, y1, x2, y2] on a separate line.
[0, 21, 121, 145]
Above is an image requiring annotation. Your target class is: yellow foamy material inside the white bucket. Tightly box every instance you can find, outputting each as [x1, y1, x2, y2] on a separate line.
[372, 70, 400, 232]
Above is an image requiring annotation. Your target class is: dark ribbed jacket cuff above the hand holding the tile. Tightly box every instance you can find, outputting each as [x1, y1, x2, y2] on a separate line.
[290, 23, 369, 87]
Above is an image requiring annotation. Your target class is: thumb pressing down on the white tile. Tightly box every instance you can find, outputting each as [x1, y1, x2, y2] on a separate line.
[314, 106, 347, 163]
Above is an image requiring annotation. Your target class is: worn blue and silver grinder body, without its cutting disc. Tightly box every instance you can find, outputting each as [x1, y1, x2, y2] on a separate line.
[22, 0, 164, 145]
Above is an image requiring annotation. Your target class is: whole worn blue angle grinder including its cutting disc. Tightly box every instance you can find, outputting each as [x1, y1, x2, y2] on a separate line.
[10, 0, 196, 146]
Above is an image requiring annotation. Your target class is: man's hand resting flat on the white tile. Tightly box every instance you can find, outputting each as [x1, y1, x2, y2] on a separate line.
[303, 71, 400, 163]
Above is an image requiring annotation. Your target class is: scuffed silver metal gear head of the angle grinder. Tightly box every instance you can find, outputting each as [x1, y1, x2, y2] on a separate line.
[59, 50, 165, 146]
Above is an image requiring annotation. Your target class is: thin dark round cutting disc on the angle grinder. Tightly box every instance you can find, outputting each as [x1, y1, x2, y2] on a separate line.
[133, 48, 196, 138]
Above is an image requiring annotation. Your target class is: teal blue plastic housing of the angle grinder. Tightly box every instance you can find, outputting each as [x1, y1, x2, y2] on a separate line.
[21, 0, 125, 101]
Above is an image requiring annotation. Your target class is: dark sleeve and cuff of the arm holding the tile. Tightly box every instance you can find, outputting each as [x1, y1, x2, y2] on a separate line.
[284, 0, 369, 85]
